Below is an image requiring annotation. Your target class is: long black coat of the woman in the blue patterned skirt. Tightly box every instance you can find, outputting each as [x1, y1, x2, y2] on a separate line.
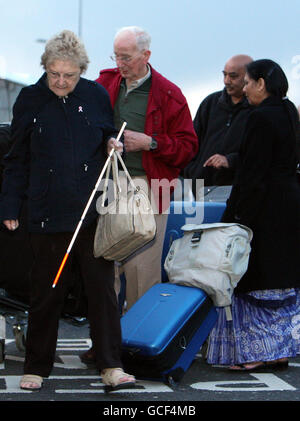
[223, 97, 300, 292]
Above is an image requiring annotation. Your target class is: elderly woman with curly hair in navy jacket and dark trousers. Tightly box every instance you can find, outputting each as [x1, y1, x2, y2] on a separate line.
[0, 31, 135, 390]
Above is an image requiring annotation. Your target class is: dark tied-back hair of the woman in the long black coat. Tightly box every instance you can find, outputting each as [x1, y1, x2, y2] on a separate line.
[246, 59, 289, 98]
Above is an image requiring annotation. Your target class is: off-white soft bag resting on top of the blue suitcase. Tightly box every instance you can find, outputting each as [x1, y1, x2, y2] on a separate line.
[164, 222, 253, 307]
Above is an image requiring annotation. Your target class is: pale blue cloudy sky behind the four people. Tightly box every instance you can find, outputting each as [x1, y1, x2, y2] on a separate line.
[0, 0, 300, 116]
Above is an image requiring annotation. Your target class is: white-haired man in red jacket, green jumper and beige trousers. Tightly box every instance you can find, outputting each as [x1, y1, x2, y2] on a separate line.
[84, 27, 198, 355]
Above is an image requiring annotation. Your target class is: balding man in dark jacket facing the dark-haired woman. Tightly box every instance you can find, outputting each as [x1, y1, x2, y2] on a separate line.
[184, 55, 252, 198]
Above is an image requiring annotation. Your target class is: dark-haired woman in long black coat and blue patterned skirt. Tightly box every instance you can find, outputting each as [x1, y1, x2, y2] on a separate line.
[207, 59, 300, 370]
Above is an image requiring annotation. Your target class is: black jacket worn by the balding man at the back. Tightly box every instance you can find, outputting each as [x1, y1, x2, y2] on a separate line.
[184, 89, 251, 195]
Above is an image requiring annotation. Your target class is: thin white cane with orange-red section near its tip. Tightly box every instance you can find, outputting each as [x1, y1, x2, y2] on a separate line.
[52, 122, 127, 288]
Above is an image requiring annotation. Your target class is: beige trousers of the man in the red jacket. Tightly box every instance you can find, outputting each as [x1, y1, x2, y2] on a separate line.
[115, 177, 168, 310]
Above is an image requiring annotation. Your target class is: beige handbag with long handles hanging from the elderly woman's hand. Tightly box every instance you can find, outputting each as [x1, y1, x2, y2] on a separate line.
[94, 151, 156, 262]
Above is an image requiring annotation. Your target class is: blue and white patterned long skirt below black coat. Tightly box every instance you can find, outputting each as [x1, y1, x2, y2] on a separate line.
[207, 289, 300, 365]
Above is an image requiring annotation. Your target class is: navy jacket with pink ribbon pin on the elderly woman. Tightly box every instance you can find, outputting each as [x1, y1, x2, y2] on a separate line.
[0, 74, 116, 232]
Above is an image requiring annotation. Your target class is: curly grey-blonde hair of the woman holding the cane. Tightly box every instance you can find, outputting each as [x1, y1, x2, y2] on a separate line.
[41, 30, 90, 73]
